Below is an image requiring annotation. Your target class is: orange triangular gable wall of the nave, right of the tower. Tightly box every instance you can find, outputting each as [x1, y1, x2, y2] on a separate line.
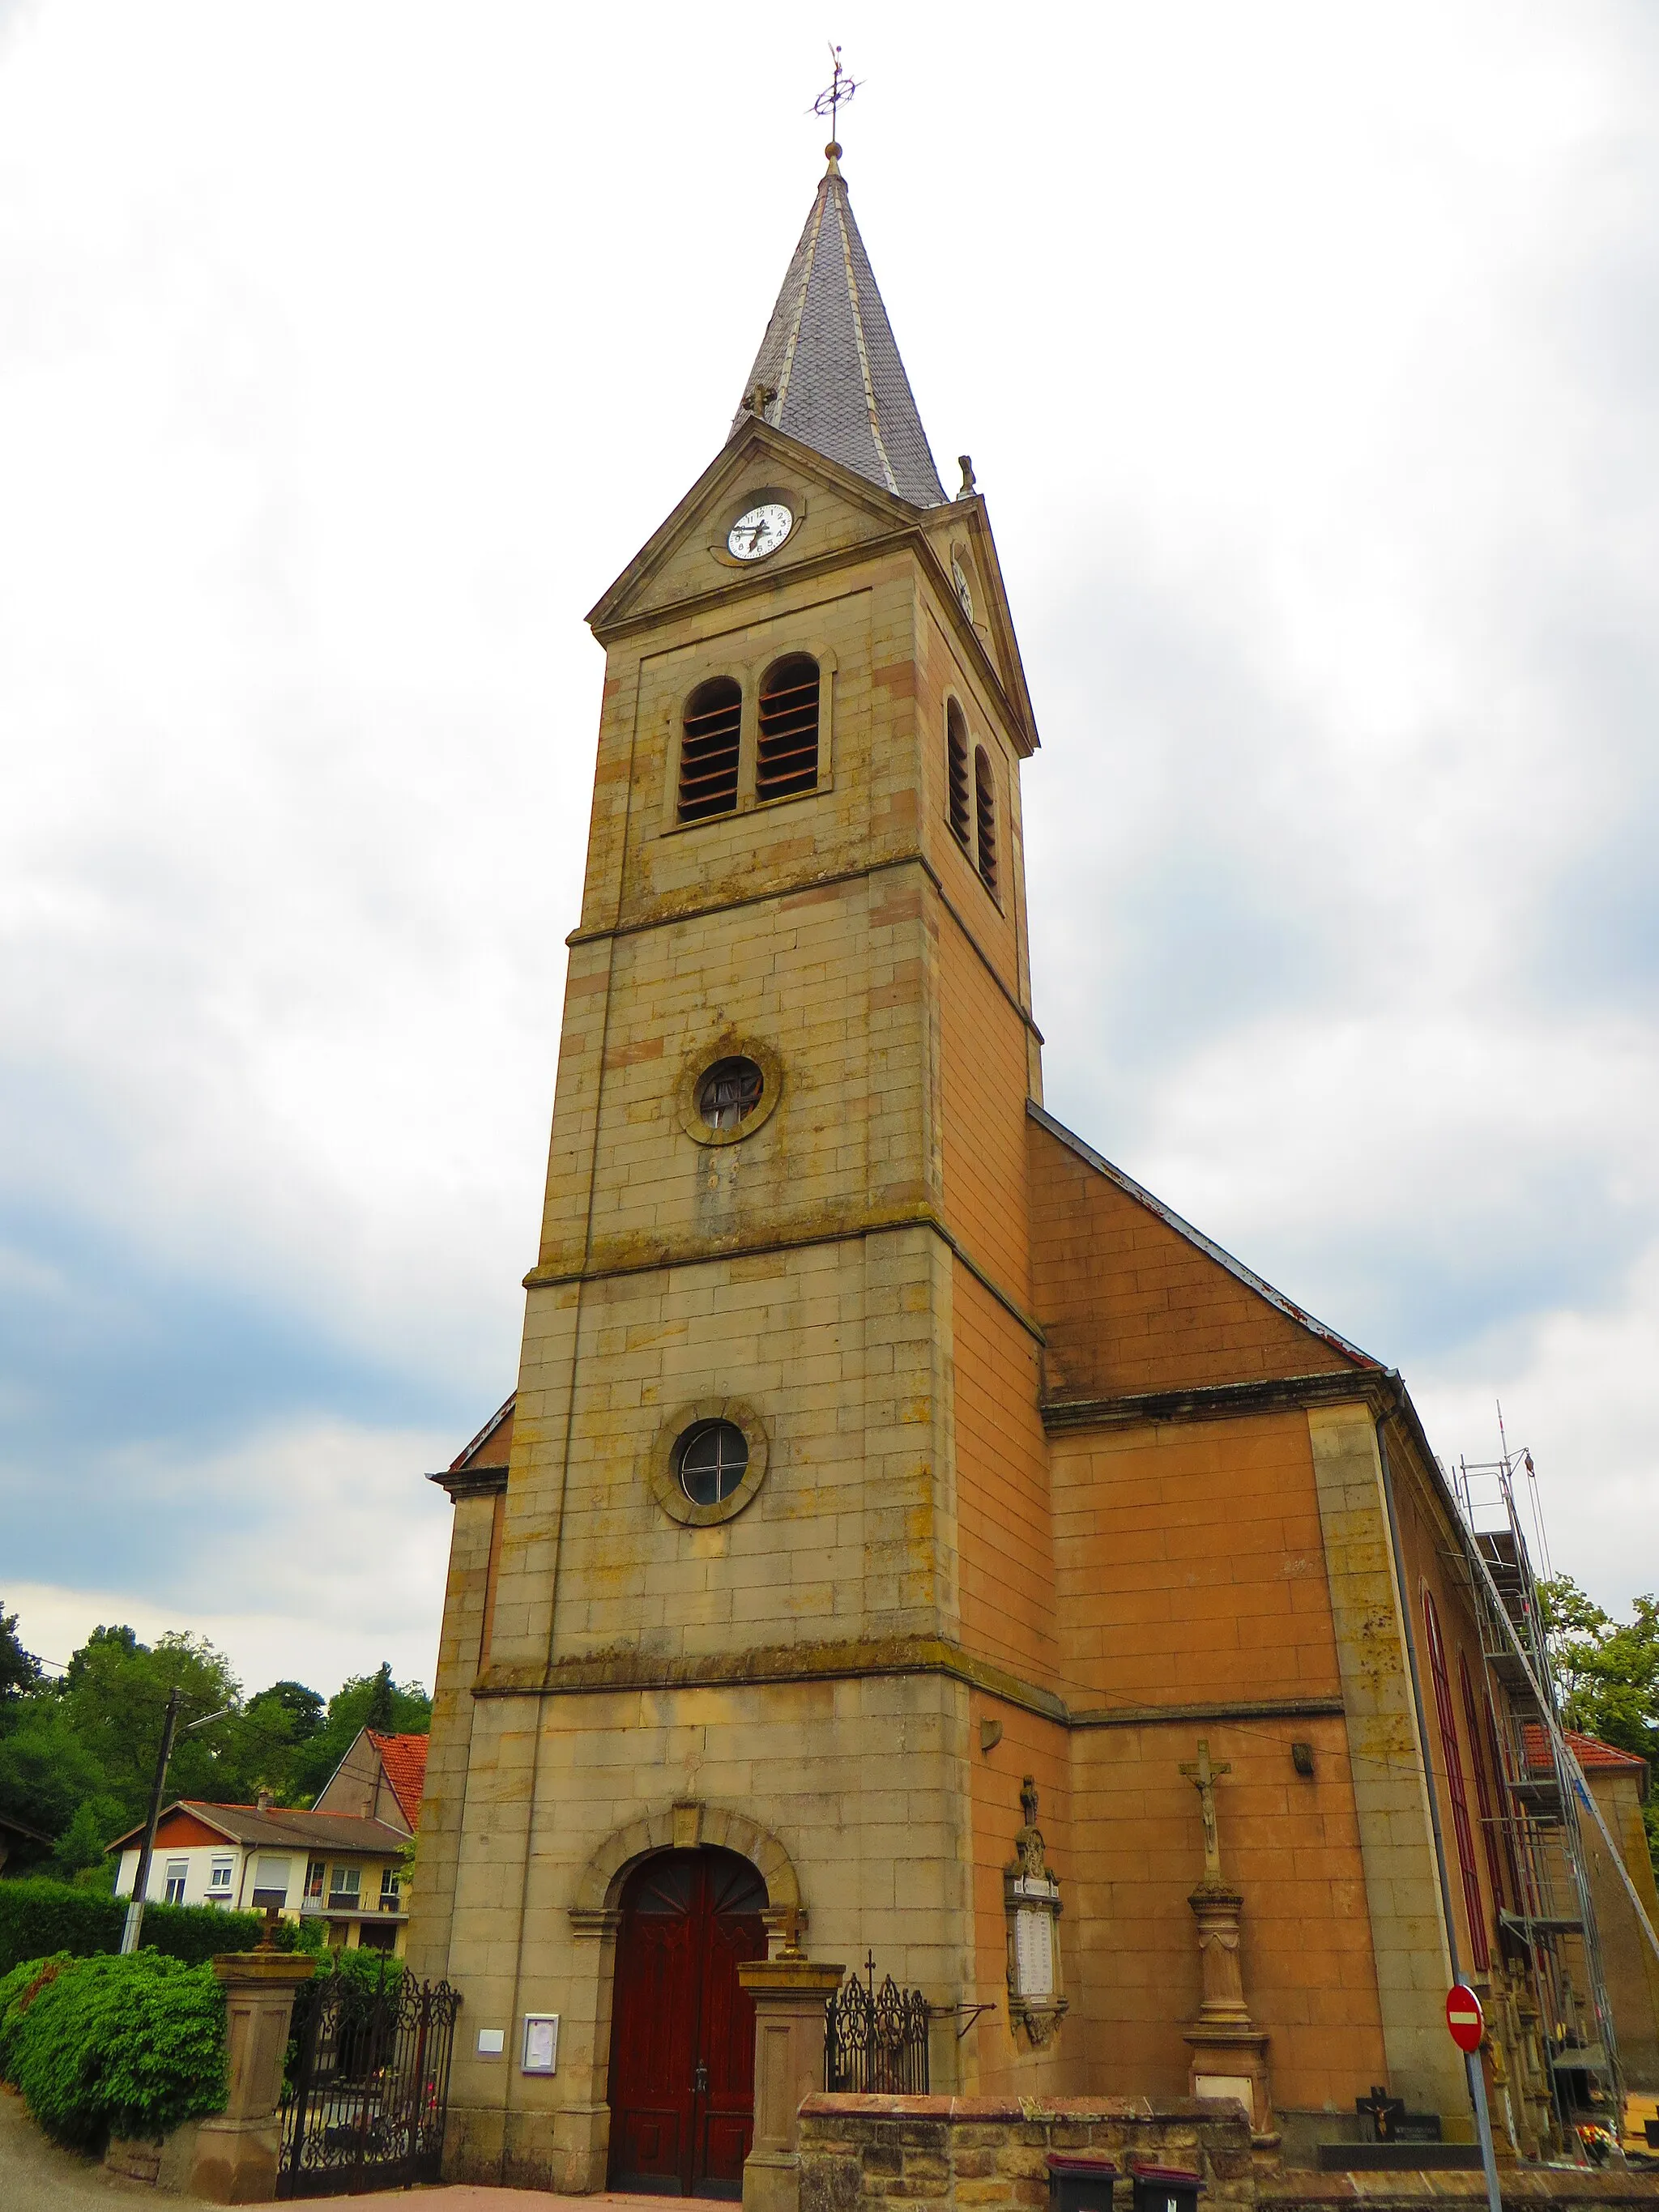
[1026, 1104, 1378, 1400]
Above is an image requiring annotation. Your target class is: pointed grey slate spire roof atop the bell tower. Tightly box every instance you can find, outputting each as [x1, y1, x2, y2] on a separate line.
[732, 146, 945, 506]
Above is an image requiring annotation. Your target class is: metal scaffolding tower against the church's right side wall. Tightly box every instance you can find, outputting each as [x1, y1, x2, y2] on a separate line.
[1447, 1416, 1623, 2148]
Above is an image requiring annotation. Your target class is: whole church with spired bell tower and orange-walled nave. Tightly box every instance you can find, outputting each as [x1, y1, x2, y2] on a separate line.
[409, 144, 1645, 2197]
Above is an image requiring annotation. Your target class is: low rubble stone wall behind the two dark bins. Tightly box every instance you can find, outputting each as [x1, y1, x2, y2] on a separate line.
[801, 2097, 1278, 2212]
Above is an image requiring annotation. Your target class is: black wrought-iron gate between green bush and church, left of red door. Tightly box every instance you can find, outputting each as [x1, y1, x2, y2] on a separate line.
[276, 1973, 460, 2197]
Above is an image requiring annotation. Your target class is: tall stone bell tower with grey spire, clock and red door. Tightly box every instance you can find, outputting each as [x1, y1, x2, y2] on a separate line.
[412, 146, 1057, 2192]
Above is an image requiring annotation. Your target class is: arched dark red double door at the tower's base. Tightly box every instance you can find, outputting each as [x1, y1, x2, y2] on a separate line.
[611, 1847, 768, 2197]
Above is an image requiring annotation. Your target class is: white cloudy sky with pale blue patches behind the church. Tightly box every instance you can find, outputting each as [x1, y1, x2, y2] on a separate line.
[0, 0, 1659, 1690]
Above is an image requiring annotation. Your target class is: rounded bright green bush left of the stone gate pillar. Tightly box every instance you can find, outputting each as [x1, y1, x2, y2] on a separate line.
[0, 1951, 226, 2150]
